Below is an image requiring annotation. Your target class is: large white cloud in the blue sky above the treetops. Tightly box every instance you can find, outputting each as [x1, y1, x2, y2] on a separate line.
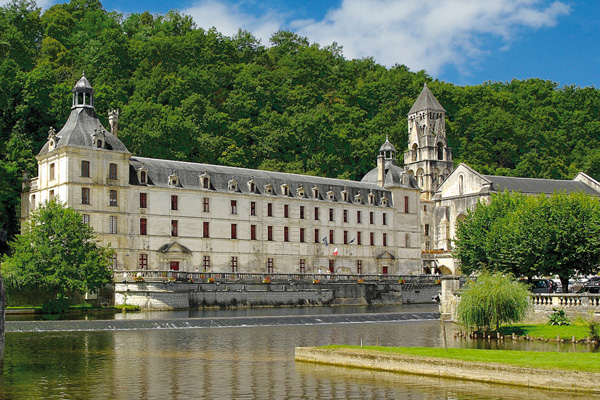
[291, 0, 570, 75]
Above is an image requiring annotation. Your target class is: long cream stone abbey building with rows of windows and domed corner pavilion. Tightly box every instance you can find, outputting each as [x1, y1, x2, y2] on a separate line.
[22, 77, 421, 274]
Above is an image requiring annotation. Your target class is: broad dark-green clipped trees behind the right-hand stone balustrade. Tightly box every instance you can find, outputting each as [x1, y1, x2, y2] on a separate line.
[454, 192, 600, 292]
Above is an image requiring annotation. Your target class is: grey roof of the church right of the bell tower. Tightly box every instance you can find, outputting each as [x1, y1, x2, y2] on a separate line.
[482, 175, 600, 196]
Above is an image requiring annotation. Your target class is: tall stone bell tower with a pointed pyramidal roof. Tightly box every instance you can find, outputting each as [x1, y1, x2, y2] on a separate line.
[404, 84, 454, 200]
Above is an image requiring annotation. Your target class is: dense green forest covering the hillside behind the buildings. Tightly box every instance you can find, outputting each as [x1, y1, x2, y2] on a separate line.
[0, 0, 600, 252]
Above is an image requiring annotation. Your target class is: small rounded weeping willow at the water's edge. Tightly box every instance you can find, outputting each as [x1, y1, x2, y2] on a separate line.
[456, 272, 530, 332]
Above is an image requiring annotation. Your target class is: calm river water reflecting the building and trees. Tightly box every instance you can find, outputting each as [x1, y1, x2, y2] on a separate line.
[0, 306, 600, 400]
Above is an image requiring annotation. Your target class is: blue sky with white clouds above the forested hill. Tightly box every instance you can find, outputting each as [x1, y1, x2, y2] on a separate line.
[7, 0, 600, 87]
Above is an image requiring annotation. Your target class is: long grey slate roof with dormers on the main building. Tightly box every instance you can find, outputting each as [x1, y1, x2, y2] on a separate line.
[129, 156, 392, 206]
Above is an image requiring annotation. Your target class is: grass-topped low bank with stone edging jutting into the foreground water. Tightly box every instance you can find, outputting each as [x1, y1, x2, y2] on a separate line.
[295, 346, 600, 393]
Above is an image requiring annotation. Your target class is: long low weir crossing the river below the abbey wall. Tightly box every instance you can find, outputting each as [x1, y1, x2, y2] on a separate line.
[6, 312, 440, 332]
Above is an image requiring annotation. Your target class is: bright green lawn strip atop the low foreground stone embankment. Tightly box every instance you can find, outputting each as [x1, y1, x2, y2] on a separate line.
[322, 345, 600, 372]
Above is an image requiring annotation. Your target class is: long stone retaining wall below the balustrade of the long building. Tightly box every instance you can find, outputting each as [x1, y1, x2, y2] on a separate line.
[114, 282, 439, 310]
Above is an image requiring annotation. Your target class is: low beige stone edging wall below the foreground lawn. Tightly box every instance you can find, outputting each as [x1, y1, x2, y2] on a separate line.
[295, 347, 600, 393]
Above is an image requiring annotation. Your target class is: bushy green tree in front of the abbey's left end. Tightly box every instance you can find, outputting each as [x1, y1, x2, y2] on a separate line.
[2, 200, 113, 310]
